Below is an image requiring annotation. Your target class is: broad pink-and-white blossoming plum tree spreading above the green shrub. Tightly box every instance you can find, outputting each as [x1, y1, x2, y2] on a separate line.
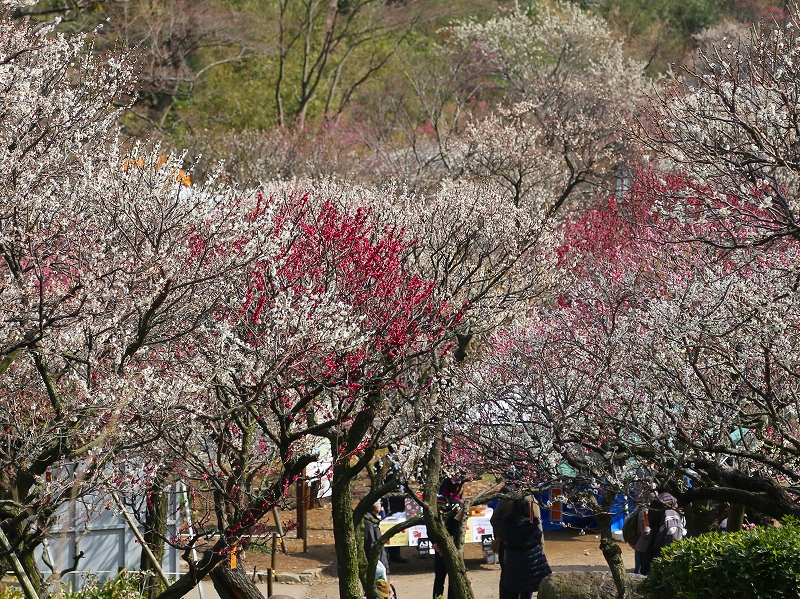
[454, 173, 798, 593]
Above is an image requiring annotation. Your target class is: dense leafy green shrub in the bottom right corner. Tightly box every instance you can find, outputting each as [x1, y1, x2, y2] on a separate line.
[640, 522, 800, 599]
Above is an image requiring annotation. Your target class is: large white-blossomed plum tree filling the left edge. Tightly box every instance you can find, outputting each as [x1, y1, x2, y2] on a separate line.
[0, 9, 276, 595]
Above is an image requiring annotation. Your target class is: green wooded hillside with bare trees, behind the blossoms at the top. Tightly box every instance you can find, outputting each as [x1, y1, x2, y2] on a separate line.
[9, 0, 786, 185]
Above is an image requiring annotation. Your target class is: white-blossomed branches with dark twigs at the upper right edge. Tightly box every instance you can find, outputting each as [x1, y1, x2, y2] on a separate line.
[640, 9, 800, 246]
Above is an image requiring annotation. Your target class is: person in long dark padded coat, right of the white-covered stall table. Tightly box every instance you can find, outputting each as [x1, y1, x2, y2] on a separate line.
[500, 497, 552, 599]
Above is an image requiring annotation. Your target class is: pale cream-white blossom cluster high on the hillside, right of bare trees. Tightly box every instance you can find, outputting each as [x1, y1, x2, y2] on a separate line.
[448, 3, 644, 208]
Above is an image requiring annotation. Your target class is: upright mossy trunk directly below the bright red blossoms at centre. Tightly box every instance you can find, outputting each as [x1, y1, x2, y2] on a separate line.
[331, 464, 361, 599]
